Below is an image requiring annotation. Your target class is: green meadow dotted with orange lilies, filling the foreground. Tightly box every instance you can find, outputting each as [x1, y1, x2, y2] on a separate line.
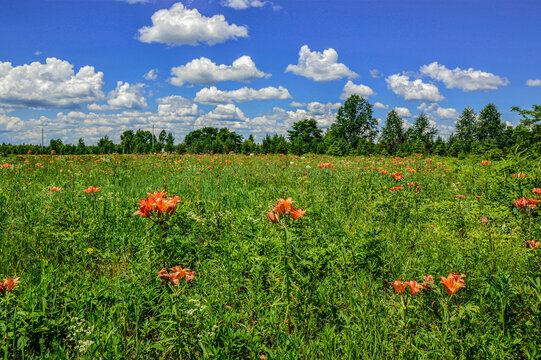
[0, 154, 541, 359]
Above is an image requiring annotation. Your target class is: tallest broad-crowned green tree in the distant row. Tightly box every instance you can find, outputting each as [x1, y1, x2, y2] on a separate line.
[331, 95, 377, 148]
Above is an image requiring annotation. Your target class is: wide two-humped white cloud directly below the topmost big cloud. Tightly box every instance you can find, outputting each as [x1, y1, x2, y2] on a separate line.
[169, 56, 270, 86]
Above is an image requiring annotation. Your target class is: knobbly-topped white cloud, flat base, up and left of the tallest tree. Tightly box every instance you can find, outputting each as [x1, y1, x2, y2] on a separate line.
[286, 45, 359, 82]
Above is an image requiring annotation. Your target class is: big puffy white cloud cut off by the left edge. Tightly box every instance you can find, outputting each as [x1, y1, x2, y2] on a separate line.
[0, 58, 104, 109]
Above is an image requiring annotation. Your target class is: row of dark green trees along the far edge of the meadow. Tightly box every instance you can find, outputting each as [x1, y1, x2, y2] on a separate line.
[0, 95, 541, 159]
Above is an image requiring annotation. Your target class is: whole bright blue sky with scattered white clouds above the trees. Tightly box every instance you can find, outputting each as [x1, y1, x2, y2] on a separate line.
[0, 0, 541, 143]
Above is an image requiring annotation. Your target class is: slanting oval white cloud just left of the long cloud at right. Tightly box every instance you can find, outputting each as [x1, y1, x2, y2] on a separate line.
[385, 74, 445, 102]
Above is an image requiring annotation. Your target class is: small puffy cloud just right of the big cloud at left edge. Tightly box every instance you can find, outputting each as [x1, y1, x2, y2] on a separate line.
[87, 81, 147, 110]
